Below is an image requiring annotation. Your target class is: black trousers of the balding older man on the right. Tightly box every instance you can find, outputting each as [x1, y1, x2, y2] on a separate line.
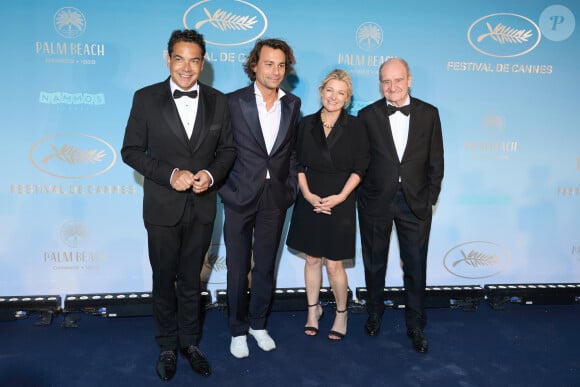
[359, 188, 431, 329]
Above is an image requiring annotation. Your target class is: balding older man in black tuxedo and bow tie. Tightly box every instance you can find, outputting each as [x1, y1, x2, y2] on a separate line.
[358, 58, 443, 352]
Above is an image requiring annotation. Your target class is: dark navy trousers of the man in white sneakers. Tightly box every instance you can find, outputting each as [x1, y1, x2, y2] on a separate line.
[224, 183, 286, 336]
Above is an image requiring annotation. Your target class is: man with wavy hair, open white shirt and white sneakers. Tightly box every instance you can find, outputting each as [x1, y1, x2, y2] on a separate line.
[219, 39, 301, 358]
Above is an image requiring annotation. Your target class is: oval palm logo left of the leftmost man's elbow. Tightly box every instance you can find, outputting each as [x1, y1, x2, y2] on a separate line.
[30, 134, 117, 179]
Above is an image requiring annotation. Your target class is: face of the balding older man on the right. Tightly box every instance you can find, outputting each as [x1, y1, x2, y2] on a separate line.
[380, 59, 412, 106]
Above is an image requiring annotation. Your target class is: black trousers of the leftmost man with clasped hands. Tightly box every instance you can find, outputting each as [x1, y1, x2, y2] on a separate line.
[145, 193, 213, 350]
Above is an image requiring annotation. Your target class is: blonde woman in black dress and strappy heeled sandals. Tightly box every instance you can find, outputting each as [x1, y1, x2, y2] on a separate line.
[286, 69, 369, 340]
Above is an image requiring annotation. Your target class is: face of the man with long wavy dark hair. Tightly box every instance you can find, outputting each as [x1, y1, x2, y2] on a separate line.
[253, 46, 286, 91]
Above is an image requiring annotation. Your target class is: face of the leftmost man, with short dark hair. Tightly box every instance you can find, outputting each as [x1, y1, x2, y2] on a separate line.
[167, 42, 204, 91]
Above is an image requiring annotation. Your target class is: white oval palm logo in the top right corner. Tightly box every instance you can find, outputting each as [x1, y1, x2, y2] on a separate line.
[467, 13, 542, 58]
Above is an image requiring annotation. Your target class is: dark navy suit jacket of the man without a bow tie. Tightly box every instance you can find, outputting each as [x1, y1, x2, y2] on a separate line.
[219, 83, 301, 213]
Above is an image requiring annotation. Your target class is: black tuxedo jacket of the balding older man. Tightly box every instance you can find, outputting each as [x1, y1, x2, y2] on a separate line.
[358, 97, 443, 219]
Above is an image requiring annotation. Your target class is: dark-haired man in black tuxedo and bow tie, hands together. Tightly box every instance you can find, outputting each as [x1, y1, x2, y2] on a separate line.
[121, 30, 236, 380]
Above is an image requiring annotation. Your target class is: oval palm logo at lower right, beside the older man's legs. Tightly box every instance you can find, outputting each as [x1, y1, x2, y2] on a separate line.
[443, 241, 511, 279]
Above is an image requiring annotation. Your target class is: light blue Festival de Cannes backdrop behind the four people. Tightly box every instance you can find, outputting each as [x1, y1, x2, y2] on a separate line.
[0, 0, 580, 295]
